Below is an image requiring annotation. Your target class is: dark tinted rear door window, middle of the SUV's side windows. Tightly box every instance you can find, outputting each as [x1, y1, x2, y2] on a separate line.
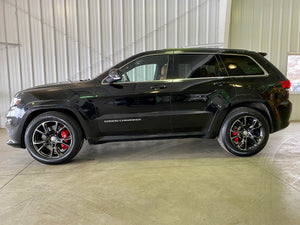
[174, 54, 221, 78]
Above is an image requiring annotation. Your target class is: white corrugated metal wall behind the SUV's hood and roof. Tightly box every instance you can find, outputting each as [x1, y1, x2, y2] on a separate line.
[0, 0, 227, 127]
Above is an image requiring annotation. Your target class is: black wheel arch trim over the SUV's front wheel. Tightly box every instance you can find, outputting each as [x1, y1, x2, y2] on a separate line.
[21, 108, 86, 148]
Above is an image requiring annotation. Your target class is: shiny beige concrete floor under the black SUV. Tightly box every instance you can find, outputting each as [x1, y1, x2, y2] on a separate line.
[0, 123, 300, 225]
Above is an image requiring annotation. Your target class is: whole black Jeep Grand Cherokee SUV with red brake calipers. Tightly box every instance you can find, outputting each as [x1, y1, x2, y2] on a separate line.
[7, 48, 291, 164]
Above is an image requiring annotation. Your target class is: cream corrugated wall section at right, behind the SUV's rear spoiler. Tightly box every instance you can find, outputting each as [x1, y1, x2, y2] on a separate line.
[229, 0, 300, 120]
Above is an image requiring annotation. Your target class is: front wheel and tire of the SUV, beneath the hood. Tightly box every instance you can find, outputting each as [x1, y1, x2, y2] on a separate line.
[25, 111, 83, 164]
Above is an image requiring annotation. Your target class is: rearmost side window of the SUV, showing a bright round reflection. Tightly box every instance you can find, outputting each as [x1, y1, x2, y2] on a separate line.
[220, 55, 264, 76]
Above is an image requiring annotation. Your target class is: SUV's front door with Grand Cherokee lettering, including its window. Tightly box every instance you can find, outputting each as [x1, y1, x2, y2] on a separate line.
[98, 55, 172, 135]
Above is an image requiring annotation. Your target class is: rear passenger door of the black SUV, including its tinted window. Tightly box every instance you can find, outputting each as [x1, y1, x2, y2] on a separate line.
[171, 53, 235, 135]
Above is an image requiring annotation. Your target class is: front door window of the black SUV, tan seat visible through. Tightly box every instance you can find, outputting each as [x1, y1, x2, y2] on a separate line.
[120, 55, 169, 82]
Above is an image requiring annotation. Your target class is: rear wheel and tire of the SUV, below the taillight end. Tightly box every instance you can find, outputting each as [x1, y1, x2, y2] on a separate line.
[218, 107, 269, 156]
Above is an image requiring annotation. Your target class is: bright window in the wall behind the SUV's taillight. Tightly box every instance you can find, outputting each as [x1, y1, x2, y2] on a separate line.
[287, 53, 300, 92]
